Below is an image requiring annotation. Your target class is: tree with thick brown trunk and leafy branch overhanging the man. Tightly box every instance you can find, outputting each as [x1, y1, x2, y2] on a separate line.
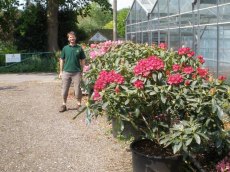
[47, 0, 111, 51]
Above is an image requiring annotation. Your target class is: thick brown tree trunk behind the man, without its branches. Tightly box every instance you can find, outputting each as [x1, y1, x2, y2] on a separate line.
[47, 0, 59, 51]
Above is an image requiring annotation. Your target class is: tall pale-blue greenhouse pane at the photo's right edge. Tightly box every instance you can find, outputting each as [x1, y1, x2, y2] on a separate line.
[218, 24, 230, 81]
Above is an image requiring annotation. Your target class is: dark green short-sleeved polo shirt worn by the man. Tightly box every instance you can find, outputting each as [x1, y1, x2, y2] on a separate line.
[61, 45, 85, 72]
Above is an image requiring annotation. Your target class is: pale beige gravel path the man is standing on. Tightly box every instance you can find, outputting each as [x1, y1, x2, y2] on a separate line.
[0, 74, 132, 172]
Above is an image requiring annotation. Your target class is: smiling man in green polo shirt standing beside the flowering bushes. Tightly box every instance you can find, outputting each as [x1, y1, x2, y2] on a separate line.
[59, 31, 85, 112]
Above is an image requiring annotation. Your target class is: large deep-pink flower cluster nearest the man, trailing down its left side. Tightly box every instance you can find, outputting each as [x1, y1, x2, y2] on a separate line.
[94, 70, 125, 100]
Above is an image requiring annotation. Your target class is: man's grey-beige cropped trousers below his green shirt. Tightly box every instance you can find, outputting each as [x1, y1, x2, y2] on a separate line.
[62, 72, 82, 100]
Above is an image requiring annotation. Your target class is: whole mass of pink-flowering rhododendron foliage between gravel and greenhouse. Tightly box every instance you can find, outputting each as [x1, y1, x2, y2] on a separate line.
[83, 42, 230, 167]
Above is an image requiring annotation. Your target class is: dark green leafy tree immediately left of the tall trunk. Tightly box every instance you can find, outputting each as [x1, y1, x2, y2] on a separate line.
[14, 3, 47, 52]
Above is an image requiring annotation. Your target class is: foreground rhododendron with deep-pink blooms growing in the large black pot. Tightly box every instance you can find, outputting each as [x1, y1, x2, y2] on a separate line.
[128, 45, 229, 171]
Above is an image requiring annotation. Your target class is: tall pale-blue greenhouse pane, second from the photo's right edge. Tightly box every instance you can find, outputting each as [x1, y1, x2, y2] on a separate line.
[200, 26, 217, 73]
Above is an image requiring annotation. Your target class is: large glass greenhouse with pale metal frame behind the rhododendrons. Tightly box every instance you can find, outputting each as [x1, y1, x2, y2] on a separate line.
[126, 0, 230, 79]
